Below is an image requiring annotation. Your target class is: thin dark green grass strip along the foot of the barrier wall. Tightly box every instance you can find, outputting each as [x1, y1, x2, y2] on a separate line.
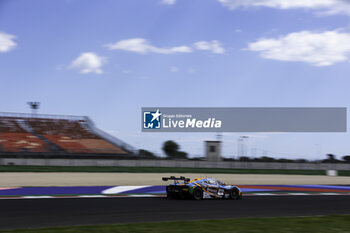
[0, 165, 350, 176]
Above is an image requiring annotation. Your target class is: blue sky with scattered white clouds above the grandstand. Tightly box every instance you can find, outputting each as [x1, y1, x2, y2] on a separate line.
[0, 0, 350, 159]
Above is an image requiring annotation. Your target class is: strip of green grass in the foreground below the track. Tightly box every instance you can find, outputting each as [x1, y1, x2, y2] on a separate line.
[0, 215, 350, 233]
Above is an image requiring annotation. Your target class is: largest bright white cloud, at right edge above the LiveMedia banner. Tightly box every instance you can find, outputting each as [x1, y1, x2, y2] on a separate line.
[248, 30, 350, 66]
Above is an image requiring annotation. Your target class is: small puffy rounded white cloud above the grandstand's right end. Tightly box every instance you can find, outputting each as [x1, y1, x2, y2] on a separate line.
[70, 52, 106, 74]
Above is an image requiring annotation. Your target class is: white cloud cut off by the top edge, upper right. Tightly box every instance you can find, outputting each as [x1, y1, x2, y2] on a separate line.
[217, 0, 350, 14]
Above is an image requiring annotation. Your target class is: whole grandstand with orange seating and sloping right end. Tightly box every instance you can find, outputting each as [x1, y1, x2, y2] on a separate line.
[0, 113, 135, 156]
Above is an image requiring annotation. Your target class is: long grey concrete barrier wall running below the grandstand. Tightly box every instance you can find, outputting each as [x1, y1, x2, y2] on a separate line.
[0, 158, 350, 170]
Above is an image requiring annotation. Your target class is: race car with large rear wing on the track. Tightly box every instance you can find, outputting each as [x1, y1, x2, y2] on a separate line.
[162, 176, 242, 200]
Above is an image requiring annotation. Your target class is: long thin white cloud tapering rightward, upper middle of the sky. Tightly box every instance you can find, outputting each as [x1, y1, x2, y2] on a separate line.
[106, 38, 192, 54]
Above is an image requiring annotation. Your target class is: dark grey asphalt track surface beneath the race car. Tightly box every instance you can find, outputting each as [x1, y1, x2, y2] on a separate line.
[0, 195, 350, 229]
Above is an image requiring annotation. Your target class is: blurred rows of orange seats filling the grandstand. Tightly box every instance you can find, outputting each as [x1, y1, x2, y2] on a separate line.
[0, 117, 128, 154]
